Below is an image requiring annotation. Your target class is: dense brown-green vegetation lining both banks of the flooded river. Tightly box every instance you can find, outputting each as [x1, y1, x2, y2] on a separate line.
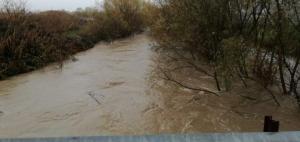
[0, 0, 300, 104]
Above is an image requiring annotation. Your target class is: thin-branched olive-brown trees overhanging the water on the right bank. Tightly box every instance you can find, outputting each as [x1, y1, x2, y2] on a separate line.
[151, 0, 300, 104]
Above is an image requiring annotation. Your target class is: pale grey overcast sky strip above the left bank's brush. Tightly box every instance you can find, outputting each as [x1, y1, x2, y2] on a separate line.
[26, 0, 101, 11]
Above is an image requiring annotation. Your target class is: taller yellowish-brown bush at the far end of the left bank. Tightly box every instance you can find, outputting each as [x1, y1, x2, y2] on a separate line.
[82, 0, 144, 42]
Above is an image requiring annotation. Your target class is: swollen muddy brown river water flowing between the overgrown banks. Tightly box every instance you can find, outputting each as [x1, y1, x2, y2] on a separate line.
[0, 34, 300, 138]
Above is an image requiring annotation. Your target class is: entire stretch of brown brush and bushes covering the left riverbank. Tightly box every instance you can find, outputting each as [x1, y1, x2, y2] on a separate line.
[0, 0, 143, 79]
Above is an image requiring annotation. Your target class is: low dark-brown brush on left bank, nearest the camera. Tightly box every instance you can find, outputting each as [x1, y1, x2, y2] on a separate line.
[0, 1, 91, 79]
